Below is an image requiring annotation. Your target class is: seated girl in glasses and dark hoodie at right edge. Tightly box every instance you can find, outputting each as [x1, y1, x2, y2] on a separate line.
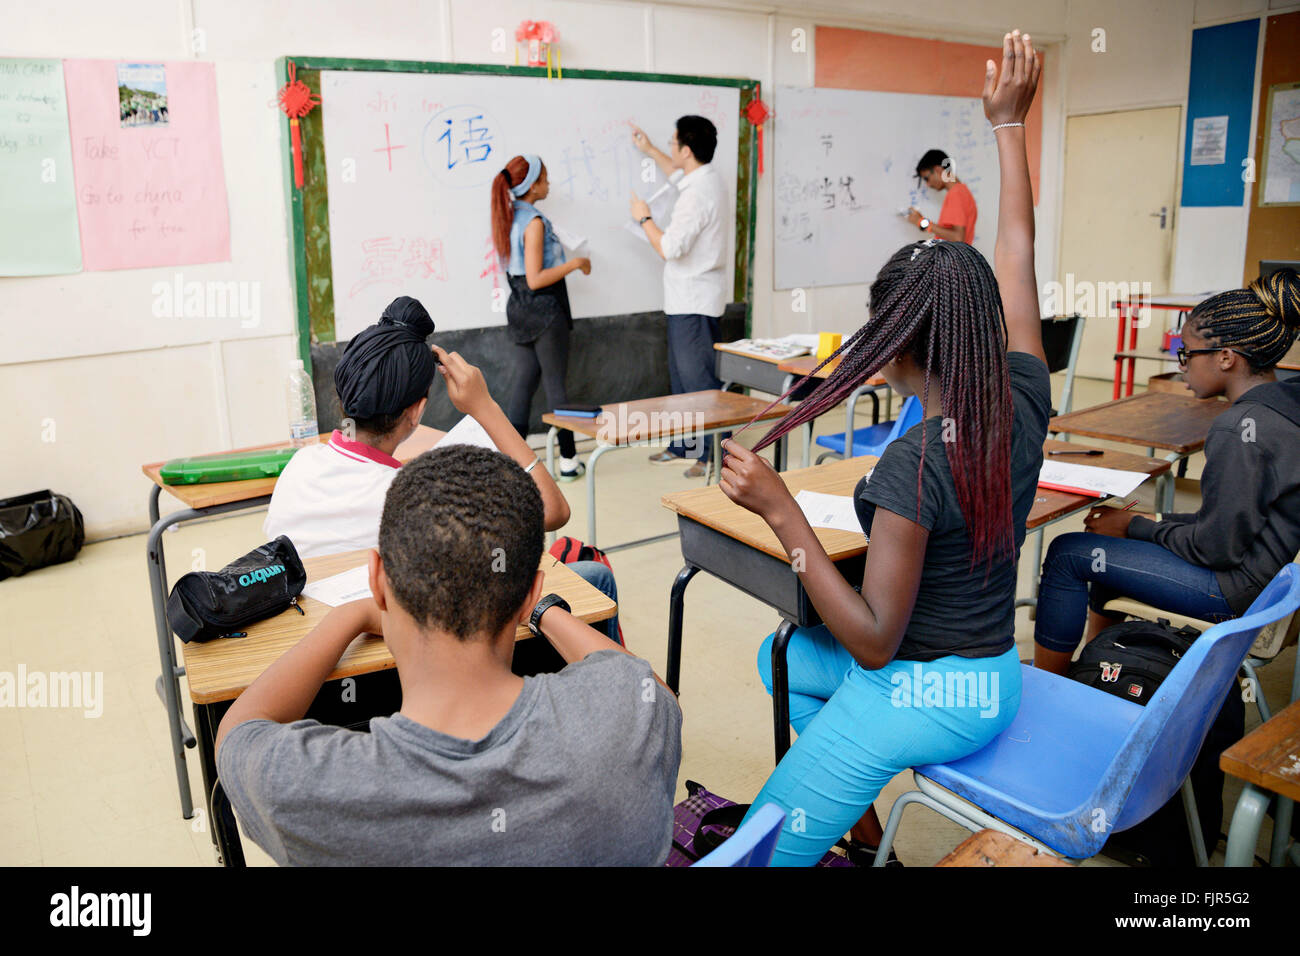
[1034, 269, 1300, 674]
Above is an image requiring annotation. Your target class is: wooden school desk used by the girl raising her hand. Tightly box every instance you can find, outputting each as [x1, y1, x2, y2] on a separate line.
[662, 442, 1169, 762]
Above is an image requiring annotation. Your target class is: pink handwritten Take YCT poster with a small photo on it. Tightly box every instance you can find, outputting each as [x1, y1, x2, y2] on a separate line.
[64, 60, 230, 269]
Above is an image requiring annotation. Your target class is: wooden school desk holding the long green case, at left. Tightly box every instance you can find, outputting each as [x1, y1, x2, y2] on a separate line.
[140, 425, 445, 819]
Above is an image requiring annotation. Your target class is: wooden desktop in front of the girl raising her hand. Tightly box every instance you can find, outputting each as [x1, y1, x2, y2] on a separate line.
[660, 440, 1170, 561]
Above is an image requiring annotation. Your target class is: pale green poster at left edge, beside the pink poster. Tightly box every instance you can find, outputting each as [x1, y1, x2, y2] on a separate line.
[0, 59, 81, 276]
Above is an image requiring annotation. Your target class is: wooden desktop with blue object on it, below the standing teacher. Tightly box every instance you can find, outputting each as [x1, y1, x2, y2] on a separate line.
[542, 389, 790, 445]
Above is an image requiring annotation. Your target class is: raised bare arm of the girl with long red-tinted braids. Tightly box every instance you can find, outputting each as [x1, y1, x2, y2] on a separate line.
[983, 30, 1047, 362]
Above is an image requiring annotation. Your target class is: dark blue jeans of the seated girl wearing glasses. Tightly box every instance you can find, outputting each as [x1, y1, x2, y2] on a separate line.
[1034, 531, 1236, 652]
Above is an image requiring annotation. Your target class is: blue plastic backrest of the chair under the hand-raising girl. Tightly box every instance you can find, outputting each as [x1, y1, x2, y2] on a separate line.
[1086, 564, 1300, 830]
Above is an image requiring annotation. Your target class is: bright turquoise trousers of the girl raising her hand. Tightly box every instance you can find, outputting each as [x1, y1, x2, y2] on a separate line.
[750, 624, 1021, 866]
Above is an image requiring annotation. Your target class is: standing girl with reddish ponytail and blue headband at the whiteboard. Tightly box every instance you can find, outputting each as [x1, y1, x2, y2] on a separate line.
[491, 153, 592, 481]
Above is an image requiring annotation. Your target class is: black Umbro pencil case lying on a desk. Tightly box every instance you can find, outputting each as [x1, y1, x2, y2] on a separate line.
[166, 535, 307, 644]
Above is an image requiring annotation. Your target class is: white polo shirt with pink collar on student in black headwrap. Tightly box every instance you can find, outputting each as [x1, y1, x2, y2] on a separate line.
[261, 429, 402, 558]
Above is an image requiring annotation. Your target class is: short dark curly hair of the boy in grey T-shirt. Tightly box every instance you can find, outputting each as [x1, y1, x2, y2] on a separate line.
[380, 445, 545, 640]
